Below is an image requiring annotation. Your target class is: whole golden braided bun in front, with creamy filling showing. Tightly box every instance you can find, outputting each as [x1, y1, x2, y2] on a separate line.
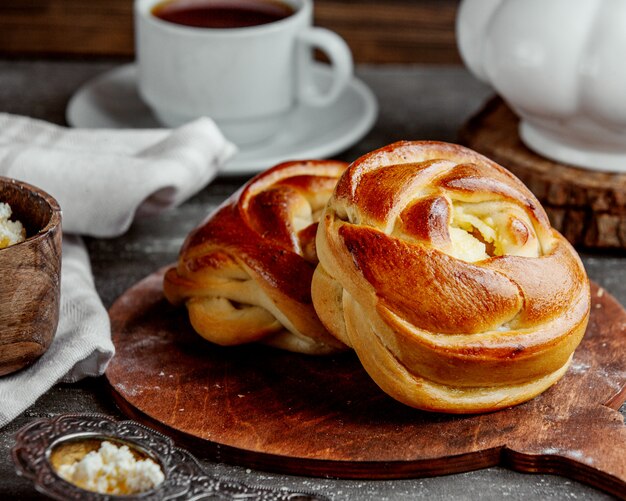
[312, 141, 590, 413]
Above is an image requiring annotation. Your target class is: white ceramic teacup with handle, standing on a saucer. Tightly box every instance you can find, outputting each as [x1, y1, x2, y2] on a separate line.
[135, 0, 353, 145]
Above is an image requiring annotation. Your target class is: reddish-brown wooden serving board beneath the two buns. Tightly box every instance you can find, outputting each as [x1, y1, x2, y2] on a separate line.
[106, 270, 626, 497]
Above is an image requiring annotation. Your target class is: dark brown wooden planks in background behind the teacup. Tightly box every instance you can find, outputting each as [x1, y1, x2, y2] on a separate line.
[0, 0, 460, 64]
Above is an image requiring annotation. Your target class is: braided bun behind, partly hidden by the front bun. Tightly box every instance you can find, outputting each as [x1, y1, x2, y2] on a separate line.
[163, 161, 347, 354]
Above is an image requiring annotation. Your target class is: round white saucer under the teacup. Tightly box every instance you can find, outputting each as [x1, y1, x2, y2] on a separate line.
[66, 64, 378, 174]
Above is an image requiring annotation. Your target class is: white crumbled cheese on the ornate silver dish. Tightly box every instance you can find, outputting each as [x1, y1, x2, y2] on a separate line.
[58, 441, 165, 494]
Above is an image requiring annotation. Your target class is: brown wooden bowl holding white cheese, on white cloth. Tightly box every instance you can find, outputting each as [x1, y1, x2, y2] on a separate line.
[0, 177, 61, 376]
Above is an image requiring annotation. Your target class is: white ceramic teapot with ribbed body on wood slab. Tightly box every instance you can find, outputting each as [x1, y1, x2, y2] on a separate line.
[456, 0, 626, 172]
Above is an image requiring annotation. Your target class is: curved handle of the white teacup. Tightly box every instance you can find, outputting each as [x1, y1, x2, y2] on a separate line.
[298, 26, 354, 106]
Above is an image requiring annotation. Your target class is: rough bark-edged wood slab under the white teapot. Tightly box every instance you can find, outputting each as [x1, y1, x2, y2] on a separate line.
[459, 97, 626, 248]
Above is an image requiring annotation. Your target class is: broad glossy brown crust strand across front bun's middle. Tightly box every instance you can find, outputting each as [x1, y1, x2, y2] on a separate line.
[338, 225, 522, 333]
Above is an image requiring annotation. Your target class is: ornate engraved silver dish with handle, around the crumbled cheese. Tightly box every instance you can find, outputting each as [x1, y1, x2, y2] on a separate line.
[11, 414, 328, 501]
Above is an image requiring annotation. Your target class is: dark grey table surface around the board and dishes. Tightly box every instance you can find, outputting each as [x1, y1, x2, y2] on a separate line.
[0, 60, 626, 501]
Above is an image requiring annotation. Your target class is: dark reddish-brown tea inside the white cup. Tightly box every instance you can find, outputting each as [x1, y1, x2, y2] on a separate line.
[152, 0, 294, 29]
